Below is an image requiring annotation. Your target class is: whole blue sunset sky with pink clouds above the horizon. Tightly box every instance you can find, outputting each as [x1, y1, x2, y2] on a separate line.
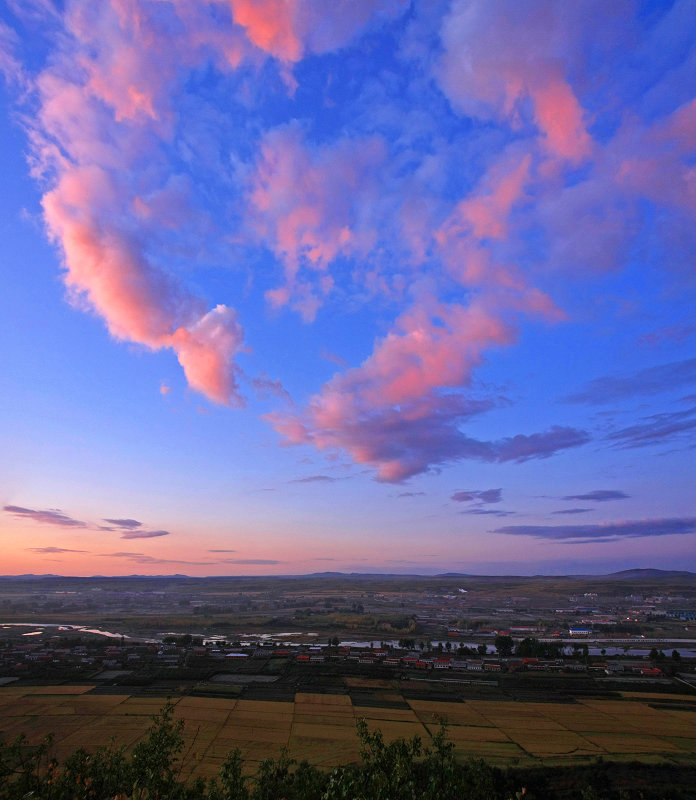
[0, 0, 696, 576]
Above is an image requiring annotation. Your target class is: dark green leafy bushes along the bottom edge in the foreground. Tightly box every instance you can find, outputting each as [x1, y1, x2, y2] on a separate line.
[0, 704, 694, 800]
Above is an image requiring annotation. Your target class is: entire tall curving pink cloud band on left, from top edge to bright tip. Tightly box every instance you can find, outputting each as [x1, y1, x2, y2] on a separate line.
[19, 3, 249, 404]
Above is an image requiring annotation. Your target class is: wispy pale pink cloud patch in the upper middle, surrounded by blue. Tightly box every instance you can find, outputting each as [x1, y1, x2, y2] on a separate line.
[250, 125, 386, 321]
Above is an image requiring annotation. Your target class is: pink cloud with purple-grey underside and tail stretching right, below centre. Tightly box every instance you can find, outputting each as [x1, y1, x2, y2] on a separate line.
[267, 298, 576, 482]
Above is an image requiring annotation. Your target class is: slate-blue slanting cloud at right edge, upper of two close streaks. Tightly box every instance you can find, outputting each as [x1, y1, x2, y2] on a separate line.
[565, 358, 696, 404]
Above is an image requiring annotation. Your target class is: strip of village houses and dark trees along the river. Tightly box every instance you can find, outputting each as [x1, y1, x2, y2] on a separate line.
[0, 631, 696, 684]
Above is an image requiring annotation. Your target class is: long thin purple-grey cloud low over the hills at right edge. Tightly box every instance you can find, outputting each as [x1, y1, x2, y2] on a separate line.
[492, 517, 696, 543]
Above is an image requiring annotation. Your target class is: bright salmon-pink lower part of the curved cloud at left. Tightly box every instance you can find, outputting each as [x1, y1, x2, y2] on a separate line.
[43, 166, 243, 403]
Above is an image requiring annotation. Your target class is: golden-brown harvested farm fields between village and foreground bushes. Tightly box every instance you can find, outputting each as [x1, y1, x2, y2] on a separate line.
[0, 681, 696, 777]
